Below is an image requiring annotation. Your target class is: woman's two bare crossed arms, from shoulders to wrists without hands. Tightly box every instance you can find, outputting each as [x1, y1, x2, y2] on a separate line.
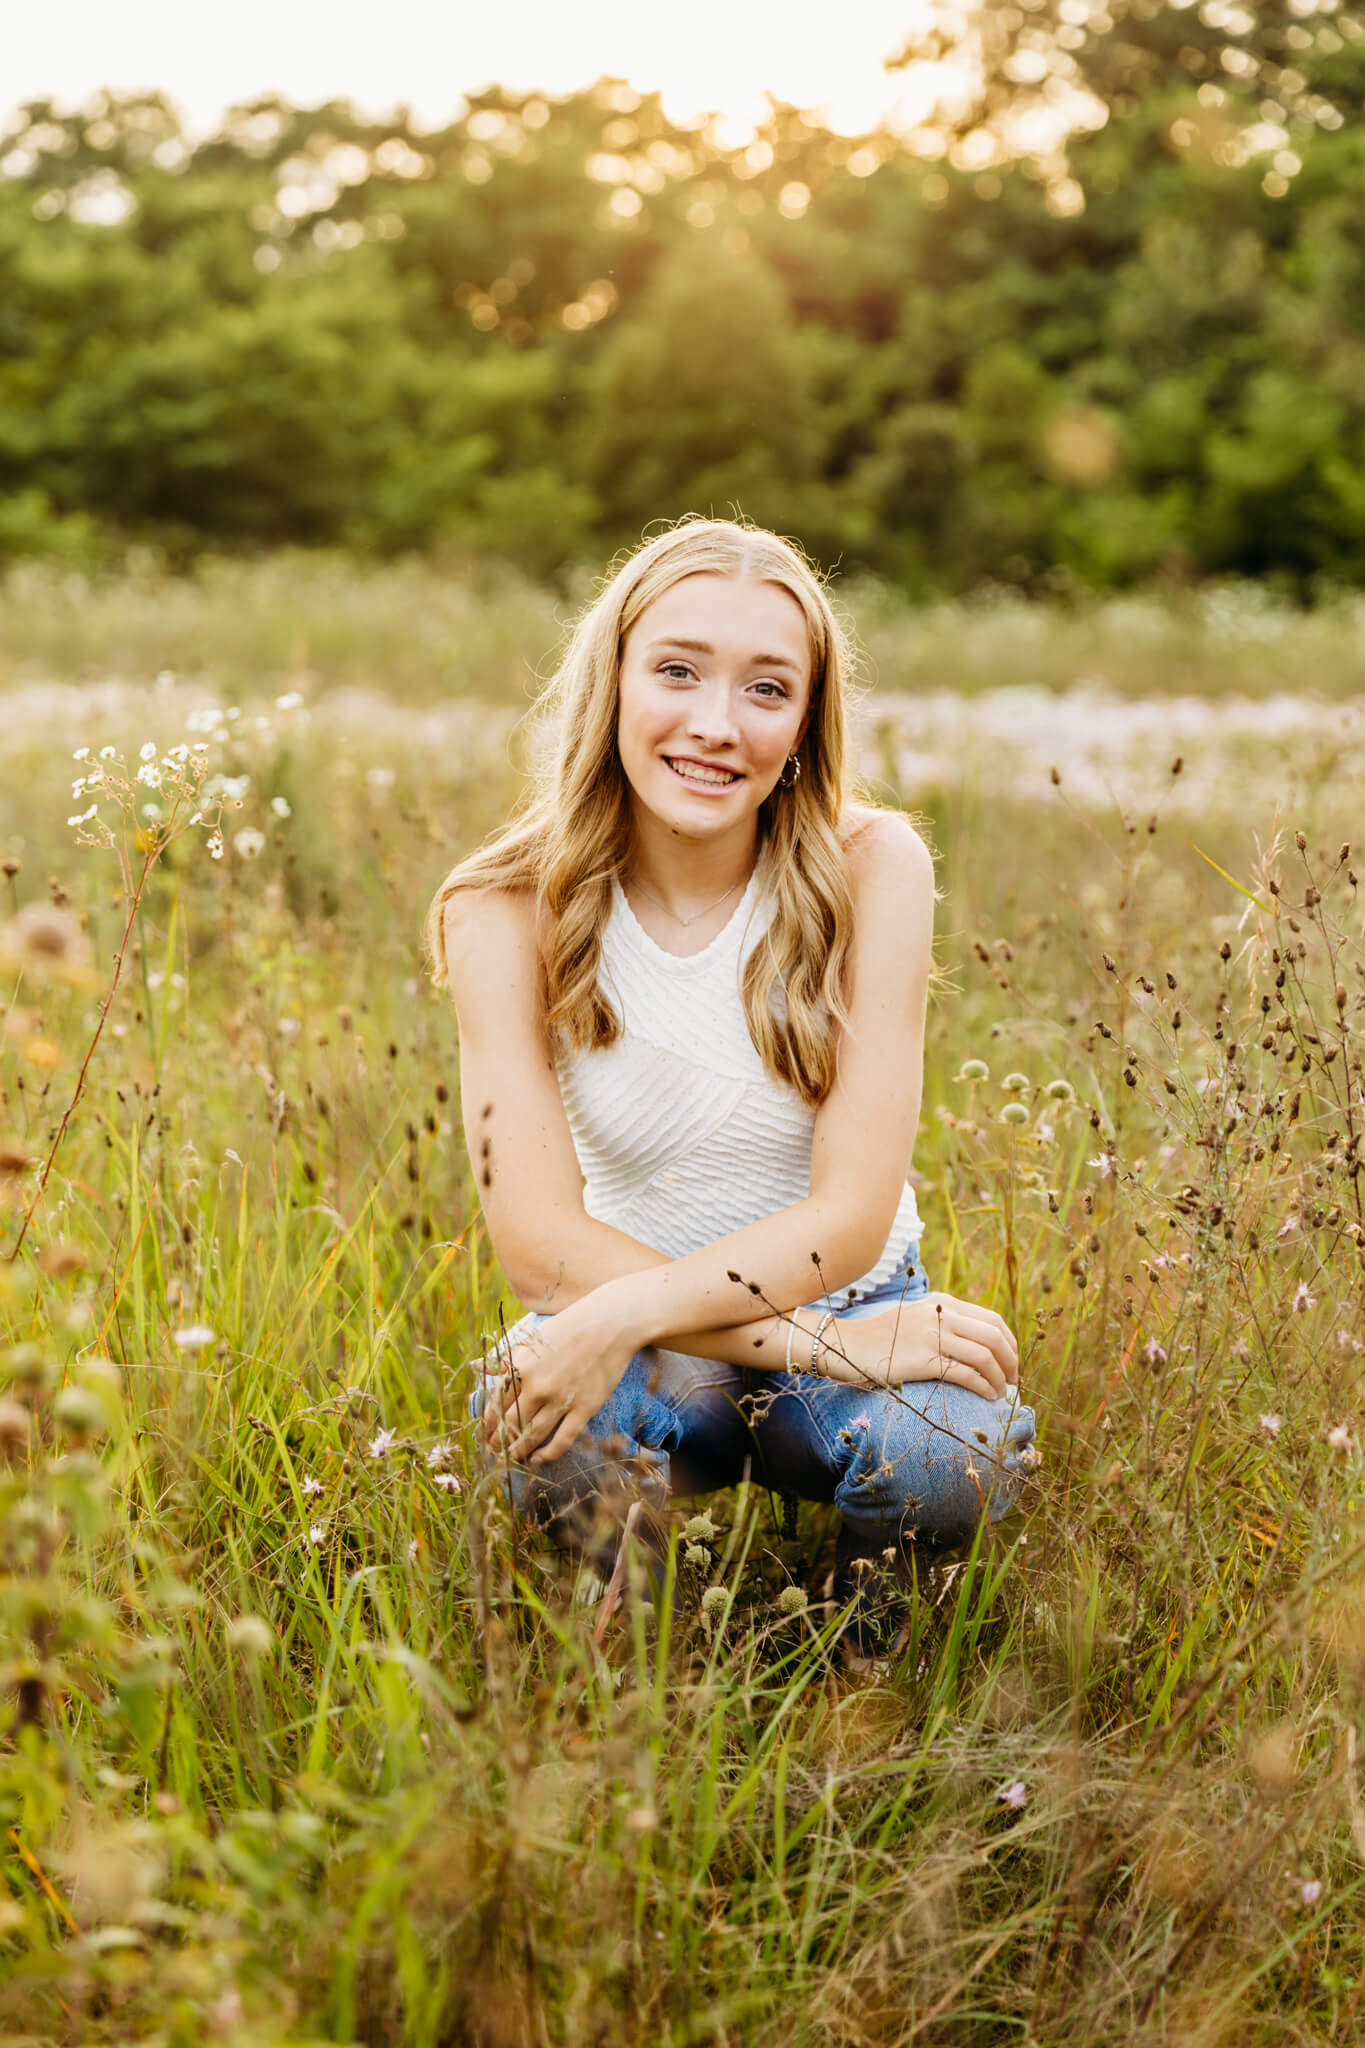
[446, 813, 933, 1364]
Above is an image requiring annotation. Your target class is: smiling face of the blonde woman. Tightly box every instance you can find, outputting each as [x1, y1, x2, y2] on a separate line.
[616, 571, 810, 840]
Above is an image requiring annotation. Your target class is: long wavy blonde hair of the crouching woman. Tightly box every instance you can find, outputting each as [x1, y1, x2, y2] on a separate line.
[426, 518, 888, 1106]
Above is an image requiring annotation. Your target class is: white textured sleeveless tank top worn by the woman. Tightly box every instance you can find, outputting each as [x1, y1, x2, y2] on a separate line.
[557, 872, 919, 1298]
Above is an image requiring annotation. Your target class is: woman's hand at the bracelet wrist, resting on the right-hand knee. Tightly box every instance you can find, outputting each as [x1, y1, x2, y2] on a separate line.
[821, 1294, 1019, 1401]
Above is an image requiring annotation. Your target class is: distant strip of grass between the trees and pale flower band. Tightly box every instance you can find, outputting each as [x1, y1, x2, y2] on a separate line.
[0, 553, 1365, 707]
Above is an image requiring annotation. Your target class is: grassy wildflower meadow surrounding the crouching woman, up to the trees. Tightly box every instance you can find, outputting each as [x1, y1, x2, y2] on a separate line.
[0, 565, 1365, 2048]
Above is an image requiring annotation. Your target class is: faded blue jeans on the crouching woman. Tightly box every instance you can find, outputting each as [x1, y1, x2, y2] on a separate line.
[469, 1245, 1036, 1589]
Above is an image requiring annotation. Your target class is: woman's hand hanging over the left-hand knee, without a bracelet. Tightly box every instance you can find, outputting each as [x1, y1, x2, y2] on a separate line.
[483, 1294, 636, 1464]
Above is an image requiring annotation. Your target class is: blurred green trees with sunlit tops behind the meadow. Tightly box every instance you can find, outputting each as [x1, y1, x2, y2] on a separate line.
[0, 0, 1365, 594]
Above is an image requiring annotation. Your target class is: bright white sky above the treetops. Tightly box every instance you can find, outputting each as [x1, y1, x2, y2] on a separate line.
[0, 0, 957, 133]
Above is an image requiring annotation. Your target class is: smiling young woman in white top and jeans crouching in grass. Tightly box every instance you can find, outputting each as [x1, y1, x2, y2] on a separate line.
[428, 520, 1036, 1638]
